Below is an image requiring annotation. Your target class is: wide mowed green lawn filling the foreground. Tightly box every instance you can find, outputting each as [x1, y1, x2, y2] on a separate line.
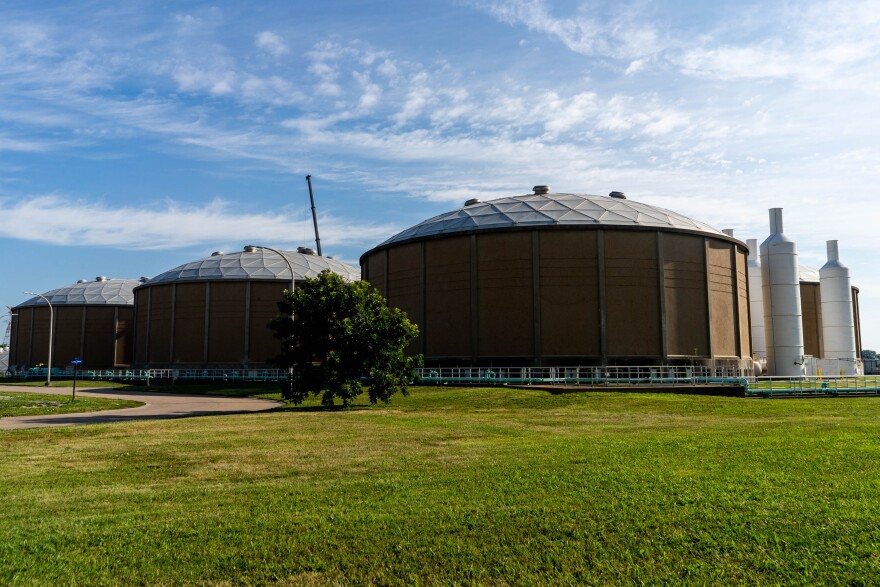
[0, 388, 880, 585]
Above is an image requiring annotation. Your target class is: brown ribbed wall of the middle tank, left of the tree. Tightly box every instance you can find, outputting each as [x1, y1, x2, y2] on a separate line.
[134, 280, 290, 369]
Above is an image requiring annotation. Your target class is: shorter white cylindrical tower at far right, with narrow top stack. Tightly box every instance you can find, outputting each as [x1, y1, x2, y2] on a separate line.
[819, 240, 858, 363]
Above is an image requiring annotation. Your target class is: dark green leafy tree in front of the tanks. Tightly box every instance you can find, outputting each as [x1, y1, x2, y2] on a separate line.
[269, 271, 422, 407]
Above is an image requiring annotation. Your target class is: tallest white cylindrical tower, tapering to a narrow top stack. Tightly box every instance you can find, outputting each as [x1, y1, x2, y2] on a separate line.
[761, 208, 804, 377]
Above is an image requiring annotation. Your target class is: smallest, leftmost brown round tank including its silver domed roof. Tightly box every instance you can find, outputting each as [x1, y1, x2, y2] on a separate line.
[9, 277, 138, 371]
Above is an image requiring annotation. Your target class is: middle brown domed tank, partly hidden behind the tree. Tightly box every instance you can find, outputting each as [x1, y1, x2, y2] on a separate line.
[134, 247, 360, 369]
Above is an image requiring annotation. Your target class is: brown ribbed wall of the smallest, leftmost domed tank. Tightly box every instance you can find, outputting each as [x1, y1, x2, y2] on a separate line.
[9, 305, 134, 369]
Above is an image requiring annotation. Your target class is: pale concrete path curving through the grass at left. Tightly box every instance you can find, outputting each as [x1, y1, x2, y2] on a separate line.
[0, 385, 283, 430]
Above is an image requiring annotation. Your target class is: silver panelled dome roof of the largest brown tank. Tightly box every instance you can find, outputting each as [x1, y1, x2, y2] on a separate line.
[377, 191, 731, 248]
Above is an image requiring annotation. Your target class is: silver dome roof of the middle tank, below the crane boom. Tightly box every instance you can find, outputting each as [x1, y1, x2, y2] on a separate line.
[143, 249, 361, 286]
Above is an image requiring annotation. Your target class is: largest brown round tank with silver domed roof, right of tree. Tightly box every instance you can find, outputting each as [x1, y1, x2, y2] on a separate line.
[360, 186, 751, 366]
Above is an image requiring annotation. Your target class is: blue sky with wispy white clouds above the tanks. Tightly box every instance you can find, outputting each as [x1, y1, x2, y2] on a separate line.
[0, 0, 880, 348]
